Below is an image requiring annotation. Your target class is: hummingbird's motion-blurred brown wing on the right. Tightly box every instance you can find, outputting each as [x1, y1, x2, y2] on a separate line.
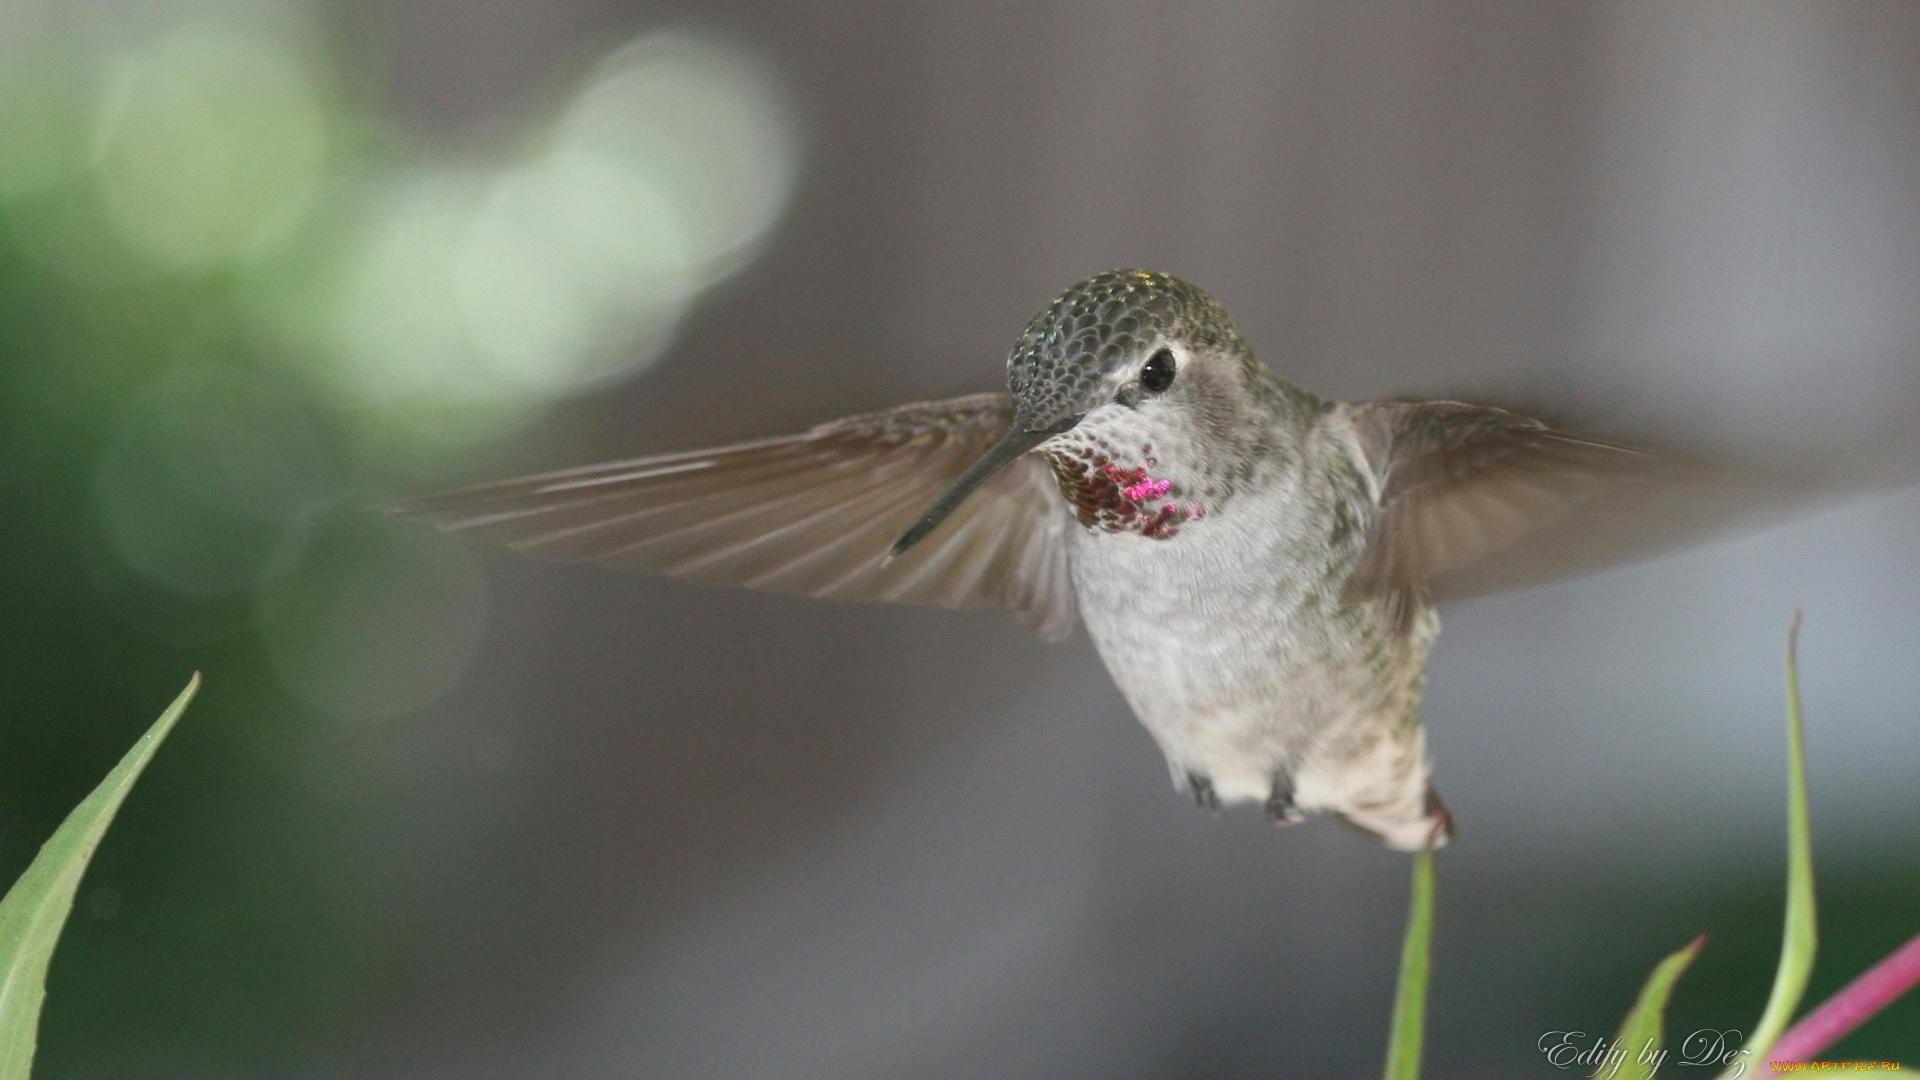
[1346, 402, 1774, 600]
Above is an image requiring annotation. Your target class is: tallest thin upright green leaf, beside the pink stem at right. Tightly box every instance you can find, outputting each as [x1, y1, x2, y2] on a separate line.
[1720, 611, 1818, 1080]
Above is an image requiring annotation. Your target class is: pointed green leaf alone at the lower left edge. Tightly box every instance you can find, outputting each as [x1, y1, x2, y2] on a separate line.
[0, 673, 200, 1080]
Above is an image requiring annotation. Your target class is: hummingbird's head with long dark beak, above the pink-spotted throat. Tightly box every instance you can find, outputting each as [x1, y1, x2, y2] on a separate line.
[893, 269, 1256, 553]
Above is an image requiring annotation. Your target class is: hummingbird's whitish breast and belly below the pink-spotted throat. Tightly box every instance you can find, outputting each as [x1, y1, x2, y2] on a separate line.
[1073, 438, 1438, 811]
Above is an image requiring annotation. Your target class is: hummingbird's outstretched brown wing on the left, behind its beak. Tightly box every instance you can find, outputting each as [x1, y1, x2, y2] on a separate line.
[390, 394, 1075, 638]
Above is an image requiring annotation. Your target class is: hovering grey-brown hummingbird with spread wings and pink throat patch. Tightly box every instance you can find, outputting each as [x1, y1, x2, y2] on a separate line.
[390, 269, 1689, 851]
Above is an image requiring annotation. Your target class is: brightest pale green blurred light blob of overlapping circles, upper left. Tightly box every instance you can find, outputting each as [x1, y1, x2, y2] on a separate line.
[301, 37, 795, 454]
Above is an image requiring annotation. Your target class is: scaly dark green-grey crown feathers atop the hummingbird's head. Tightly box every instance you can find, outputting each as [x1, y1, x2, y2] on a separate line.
[1006, 269, 1244, 430]
